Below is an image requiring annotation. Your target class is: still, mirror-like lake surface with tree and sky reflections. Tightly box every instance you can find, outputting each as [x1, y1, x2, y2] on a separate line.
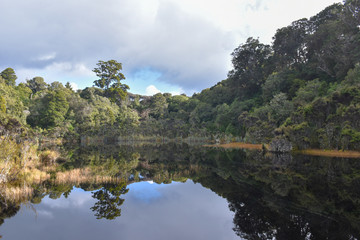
[0, 144, 360, 239]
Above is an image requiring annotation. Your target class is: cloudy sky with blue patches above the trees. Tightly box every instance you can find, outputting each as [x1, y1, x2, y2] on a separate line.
[0, 0, 339, 96]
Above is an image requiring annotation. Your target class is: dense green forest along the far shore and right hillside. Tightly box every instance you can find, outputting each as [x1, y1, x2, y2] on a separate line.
[0, 0, 360, 150]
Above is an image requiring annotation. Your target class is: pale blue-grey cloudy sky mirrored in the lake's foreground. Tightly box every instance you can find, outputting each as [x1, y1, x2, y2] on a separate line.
[0, 180, 239, 240]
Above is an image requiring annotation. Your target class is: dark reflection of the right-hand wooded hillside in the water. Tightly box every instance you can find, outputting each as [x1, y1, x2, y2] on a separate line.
[198, 152, 360, 239]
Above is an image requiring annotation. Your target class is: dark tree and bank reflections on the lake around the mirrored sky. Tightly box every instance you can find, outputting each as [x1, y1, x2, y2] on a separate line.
[0, 143, 360, 239]
